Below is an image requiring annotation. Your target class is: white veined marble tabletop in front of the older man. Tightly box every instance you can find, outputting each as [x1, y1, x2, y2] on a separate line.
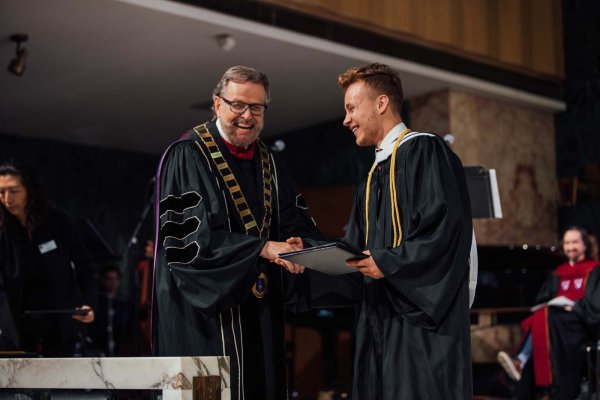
[0, 357, 231, 400]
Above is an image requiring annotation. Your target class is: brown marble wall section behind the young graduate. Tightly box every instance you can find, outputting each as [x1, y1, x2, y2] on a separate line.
[410, 89, 558, 245]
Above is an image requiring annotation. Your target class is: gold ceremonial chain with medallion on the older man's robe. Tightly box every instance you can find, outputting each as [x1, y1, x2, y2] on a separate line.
[194, 124, 272, 299]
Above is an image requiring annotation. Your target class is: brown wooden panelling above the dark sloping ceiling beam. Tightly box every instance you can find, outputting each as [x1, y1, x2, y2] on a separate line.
[260, 0, 564, 78]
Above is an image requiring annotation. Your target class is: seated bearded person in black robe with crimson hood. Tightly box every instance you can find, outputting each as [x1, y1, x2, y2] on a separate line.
[498, 227, 600, 400]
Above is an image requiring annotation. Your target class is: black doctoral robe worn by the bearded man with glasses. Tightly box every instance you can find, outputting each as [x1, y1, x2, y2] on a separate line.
[153, 122, 316, 399]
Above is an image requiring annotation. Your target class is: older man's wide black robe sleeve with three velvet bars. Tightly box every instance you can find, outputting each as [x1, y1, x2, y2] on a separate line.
[156, 141, 265, 318]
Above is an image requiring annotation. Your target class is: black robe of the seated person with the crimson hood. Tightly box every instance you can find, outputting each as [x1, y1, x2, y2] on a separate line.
[515, 267, 600, 400]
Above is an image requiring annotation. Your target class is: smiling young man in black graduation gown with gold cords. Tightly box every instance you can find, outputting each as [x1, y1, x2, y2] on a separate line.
[286, 64, 472, 400]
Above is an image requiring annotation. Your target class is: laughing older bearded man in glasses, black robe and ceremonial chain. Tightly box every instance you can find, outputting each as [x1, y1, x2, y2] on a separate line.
[153, 66, 316, 400]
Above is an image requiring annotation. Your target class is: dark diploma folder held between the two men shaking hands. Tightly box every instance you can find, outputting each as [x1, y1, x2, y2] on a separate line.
[279, 242, 369, 275]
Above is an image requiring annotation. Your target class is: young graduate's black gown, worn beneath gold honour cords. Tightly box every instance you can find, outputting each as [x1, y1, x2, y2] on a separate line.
[338, 133, 472, 400]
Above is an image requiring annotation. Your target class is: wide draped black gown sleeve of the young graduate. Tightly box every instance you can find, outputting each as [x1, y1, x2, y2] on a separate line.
[370, 136, 472, 329]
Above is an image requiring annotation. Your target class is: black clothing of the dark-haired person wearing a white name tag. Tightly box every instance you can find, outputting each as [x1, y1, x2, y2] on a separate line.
[0, 209, 96, 356]
